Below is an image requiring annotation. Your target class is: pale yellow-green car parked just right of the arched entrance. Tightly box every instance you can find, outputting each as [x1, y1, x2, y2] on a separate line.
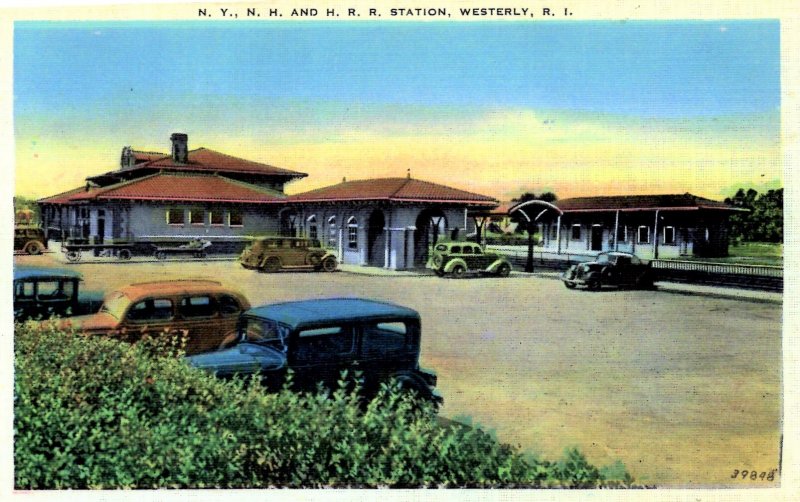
[427, 242, 511, 277]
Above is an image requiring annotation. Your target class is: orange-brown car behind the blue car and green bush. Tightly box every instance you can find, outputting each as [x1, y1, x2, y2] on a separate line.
[59, 280, 250, 354]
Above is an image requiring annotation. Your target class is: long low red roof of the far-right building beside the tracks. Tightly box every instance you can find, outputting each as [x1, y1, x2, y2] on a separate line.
[554, 193, 737, 212]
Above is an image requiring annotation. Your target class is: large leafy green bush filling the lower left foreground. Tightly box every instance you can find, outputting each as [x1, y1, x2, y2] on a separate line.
[14, 323, 632, 489]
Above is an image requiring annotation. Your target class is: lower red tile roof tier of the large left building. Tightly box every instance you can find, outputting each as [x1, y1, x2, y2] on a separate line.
[40, 173, 286, 204]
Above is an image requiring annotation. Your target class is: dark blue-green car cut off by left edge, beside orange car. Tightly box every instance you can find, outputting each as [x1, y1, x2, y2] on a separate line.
[14, 267, 103, 321]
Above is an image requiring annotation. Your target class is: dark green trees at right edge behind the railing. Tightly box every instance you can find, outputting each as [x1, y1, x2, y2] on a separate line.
[725, 188, 783, 244]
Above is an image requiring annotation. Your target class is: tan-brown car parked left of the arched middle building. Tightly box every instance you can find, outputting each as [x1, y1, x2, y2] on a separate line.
[239, 237, 337, 272]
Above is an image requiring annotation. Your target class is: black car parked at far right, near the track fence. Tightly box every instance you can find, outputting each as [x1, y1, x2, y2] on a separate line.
[561, 252, 654, 291]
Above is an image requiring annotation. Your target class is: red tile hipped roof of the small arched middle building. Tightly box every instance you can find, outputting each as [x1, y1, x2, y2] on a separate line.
[288, 178, 497, 206]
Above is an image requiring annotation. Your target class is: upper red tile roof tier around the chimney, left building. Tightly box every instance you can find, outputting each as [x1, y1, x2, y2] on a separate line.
[136, 148, 308, 178]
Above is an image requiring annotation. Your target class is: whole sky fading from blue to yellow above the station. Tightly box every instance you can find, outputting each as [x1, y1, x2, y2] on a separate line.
[14, 20, 783, 200]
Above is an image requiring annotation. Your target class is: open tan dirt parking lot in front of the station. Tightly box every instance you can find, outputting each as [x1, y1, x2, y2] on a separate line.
[15, 254, 782, 487]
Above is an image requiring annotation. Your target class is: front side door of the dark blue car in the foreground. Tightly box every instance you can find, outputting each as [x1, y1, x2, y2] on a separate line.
[289, 323, 356, 390]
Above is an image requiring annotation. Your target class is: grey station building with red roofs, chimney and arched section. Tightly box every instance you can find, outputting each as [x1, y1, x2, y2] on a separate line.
[38, 133, 498, 268]
